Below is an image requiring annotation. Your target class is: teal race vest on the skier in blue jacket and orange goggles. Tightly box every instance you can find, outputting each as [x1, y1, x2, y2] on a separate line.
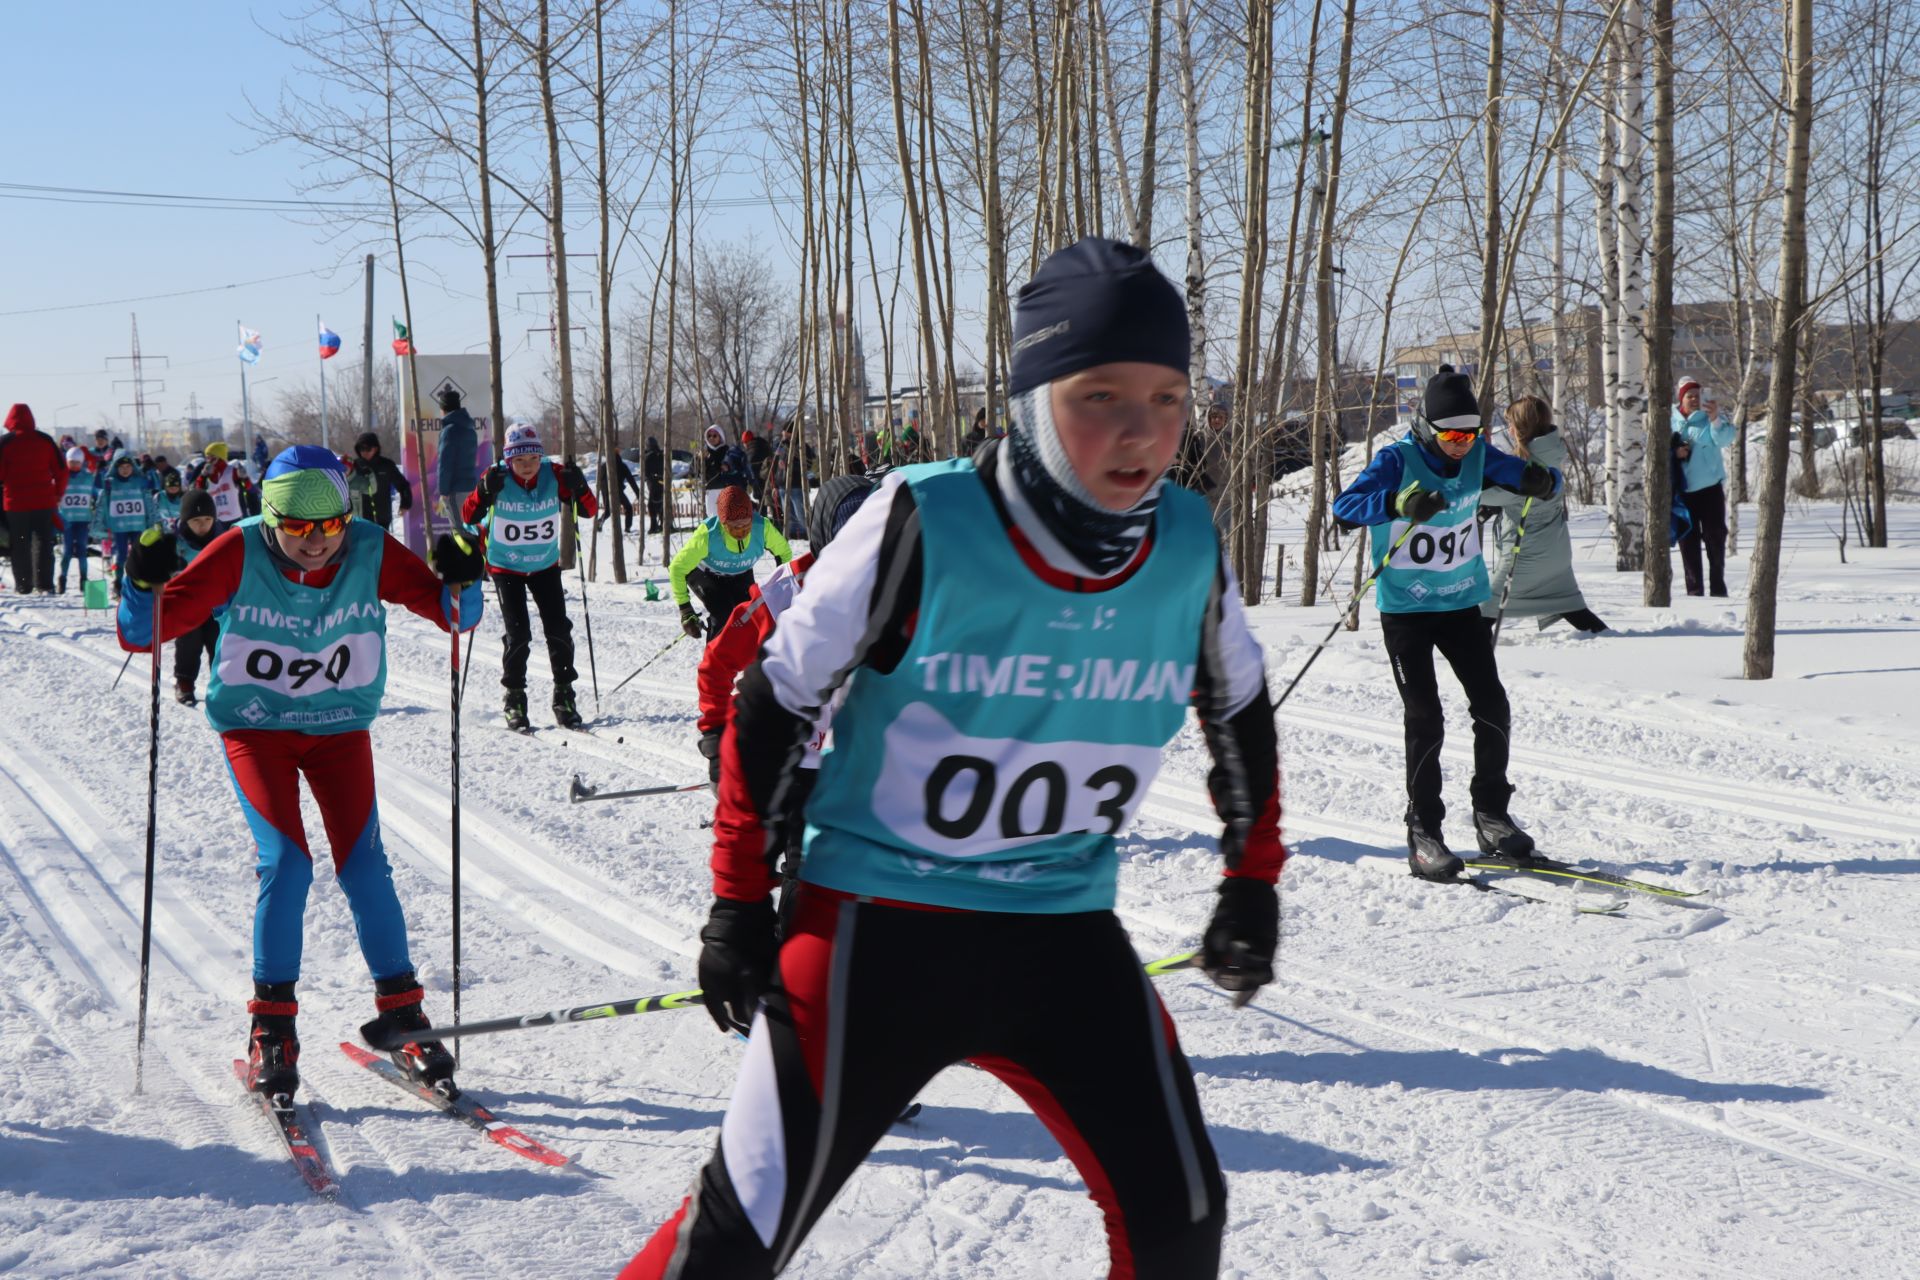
[1367, 436, 1492, 614]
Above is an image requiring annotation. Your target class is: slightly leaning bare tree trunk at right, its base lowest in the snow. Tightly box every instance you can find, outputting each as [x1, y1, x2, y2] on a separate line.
[1741, 0, 1812, 679]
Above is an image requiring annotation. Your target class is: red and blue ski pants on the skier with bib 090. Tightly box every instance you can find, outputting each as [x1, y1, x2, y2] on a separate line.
[221, 729, 413, 983]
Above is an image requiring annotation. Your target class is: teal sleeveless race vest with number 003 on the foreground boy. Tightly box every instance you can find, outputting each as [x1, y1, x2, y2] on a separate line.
[803, 459, 1219, 913]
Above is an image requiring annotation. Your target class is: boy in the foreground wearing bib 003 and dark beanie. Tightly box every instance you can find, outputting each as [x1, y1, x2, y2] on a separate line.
[624, 240, 1284, 1280]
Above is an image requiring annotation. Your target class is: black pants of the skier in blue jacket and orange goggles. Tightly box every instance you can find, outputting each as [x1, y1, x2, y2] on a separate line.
[1380, 608, 1513, 831]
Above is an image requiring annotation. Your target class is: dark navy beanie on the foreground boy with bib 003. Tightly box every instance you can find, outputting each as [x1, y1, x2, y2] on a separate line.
[1008, 236, 1192, 395]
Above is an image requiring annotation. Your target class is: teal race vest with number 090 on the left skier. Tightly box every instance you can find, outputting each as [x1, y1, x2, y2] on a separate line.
[207, 516, 386, 733]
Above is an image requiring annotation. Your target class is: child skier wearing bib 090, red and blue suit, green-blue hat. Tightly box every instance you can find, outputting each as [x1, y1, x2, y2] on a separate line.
[119, 445, 482, 1096]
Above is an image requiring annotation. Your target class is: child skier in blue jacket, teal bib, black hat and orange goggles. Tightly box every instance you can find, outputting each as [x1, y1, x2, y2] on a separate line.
[1332, 365, 1561, 881]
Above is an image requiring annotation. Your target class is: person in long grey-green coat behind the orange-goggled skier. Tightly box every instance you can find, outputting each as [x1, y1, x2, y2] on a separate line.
[1480, 395, 1607, 631]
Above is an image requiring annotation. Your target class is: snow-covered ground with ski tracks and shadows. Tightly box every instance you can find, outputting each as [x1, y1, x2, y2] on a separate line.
[0, 507, 1920, 1280]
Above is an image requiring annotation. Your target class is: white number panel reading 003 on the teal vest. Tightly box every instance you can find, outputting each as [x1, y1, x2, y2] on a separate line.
[872, 702, 1160, 858]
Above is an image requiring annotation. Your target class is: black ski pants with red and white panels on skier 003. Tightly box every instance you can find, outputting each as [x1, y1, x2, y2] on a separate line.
[620, 885, 1227, 1280]
